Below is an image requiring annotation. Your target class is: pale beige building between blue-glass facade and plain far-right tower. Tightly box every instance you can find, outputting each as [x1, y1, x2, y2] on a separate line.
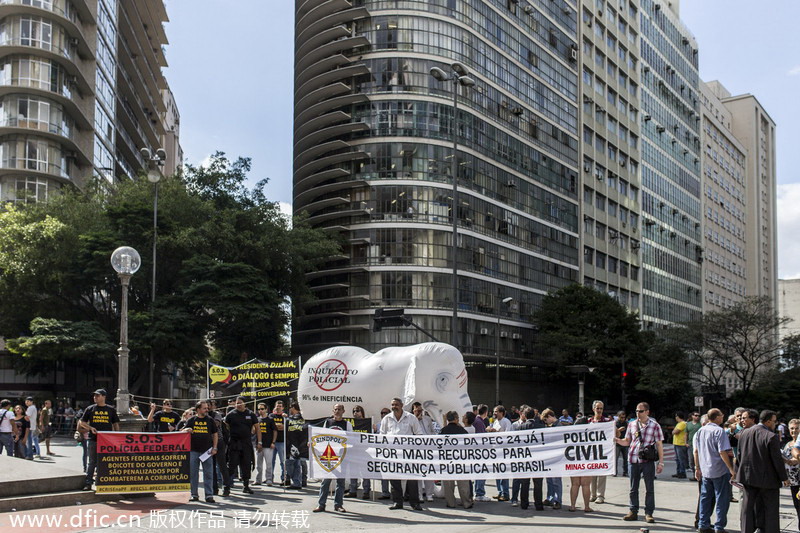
[700, 81, 753, 312]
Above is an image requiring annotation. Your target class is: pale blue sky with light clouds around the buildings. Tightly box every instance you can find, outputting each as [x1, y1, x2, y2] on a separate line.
[166, 0, 800, 278]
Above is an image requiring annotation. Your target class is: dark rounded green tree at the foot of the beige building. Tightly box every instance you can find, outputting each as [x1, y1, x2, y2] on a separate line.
[533, 284, 647, 403]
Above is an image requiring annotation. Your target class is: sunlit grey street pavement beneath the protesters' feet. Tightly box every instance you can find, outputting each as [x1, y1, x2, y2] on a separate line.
[0, 439, 798, 533]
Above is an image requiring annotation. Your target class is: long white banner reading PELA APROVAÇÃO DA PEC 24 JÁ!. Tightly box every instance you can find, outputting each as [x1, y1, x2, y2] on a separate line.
[309, 422, 615, 480]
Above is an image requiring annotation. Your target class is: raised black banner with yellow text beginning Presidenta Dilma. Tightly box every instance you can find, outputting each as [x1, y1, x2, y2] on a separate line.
[207, 359, 300, 402]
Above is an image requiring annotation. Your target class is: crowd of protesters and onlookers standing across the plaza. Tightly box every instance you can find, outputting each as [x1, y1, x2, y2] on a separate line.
[0, 389, 800, 533]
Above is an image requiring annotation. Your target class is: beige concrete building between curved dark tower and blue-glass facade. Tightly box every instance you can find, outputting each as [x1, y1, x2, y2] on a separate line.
[580, 0, 642, 309]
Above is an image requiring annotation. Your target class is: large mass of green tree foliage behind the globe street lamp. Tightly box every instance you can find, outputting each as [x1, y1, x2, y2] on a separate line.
[0, 153, 338, 390]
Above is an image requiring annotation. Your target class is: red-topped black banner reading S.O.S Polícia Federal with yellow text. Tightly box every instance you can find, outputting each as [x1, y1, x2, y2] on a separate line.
[96, 431, 191, 492]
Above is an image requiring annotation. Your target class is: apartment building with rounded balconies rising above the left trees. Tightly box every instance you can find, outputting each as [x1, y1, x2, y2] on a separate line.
[0, 0, 180, 201]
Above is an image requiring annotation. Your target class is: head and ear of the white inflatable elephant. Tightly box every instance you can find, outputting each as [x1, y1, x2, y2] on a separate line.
[403, 342, 472, 424]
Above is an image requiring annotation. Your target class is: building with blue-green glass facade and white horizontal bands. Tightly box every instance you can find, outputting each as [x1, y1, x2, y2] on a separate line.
[640, 0, 703, 329]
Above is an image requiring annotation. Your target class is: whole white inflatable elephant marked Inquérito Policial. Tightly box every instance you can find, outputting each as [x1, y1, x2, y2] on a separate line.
[298, 342, 472, 424]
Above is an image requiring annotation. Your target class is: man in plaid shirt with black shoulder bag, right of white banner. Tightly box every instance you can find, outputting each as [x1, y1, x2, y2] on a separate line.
[615, 402, 664, 524]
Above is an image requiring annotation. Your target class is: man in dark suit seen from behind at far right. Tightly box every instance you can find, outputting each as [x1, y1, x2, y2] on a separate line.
[735, 410, 789, 533]
